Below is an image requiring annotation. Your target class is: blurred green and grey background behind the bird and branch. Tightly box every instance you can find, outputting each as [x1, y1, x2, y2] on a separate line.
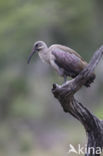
[0, 0, 103, 156]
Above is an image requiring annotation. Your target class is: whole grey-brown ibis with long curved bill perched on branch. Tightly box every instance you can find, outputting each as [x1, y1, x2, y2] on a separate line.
[27, 41, 96, 87]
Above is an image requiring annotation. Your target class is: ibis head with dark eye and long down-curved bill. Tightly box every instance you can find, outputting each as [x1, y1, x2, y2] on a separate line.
[27, 41, 47, 63]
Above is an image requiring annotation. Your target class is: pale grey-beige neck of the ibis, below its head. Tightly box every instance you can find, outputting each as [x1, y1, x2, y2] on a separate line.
[38, 48, 50, 63]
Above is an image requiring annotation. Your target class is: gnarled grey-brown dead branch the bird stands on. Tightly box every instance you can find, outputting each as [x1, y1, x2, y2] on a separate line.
[52, 46, 103, 156]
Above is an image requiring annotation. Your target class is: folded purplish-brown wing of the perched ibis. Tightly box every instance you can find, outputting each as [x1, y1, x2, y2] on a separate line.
[51, 47, 87, 77]
